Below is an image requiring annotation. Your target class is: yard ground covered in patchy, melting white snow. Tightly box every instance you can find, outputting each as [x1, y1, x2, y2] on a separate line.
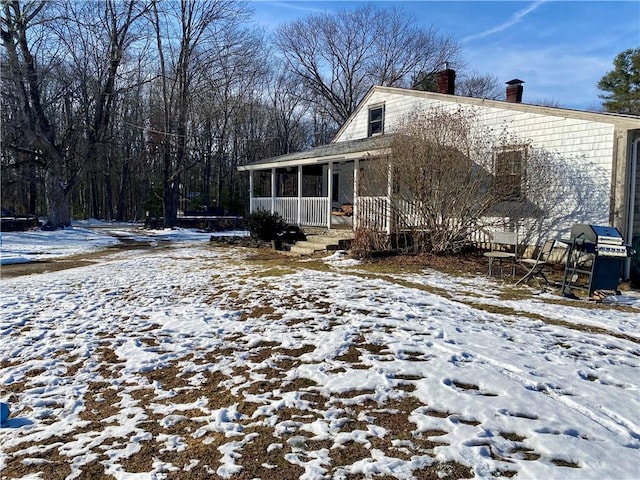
[0, 226, 640, 479]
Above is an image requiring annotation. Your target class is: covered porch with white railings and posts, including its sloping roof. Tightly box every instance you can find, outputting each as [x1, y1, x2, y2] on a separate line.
[239, 137, 391, 233]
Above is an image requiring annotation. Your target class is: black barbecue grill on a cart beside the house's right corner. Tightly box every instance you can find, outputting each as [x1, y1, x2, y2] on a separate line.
[562, 224, 633, 297]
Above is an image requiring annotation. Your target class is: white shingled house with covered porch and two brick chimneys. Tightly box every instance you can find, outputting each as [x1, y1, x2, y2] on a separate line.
[239, 70, 640, 251]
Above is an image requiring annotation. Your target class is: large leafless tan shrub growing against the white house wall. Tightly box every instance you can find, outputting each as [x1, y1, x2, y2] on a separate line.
[360, 107, 596, 253]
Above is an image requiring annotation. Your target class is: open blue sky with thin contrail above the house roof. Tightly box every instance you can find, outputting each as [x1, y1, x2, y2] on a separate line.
[251, 0, 640, 109]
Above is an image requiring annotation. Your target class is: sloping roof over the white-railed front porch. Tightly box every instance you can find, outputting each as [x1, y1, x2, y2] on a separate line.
[238, 135, 393, 171]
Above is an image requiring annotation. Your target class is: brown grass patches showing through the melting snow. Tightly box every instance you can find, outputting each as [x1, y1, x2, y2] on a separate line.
[0, 246, 624, 480]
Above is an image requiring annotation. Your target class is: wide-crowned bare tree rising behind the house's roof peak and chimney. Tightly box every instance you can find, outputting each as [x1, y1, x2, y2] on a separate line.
[275, 5, 458, 129]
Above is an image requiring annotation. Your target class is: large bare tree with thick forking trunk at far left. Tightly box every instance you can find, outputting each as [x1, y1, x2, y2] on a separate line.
[1, 0, 149, 228]
